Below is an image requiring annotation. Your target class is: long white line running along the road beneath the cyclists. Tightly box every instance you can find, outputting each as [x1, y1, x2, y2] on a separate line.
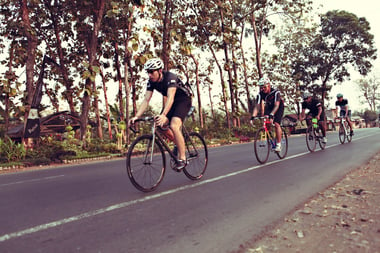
[0, 132, 372, 242]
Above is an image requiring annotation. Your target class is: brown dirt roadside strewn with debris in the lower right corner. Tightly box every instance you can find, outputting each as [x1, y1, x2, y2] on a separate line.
[236, 153, 380, 253]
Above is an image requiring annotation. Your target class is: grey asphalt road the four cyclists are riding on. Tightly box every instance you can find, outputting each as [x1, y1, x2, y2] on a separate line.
[0, 128, 380, 253]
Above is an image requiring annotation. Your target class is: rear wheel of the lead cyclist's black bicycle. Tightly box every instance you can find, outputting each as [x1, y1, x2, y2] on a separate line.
[183, 132, 208, 180]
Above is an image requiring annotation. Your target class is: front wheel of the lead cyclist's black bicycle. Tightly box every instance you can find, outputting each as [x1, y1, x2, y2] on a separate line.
[127, 135, 165, 192]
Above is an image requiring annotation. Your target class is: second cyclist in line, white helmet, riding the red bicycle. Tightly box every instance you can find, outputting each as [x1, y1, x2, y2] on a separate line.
[251, 77, 284, 152]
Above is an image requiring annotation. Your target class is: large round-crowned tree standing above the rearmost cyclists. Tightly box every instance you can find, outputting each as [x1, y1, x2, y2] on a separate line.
[293, 10, 376, 104]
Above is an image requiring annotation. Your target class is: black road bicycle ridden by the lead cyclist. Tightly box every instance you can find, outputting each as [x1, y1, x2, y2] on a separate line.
[127, 107, 208, 192]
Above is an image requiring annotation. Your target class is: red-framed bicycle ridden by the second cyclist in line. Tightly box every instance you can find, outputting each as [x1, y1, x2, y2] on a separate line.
[254, 116, 288, 164]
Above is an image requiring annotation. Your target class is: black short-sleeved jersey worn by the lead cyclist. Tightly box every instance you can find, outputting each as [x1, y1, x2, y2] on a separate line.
[147, 71, 191, 99]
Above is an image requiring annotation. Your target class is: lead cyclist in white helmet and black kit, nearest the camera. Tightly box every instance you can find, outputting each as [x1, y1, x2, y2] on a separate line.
[130, 58, 191, 171]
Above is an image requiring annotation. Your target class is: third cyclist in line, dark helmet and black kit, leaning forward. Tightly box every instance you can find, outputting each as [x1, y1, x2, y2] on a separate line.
[300, 92, 327, 143]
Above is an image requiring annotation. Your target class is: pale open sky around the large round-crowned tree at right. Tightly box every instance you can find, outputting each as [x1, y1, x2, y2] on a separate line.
[313, 0, 380, 111]
